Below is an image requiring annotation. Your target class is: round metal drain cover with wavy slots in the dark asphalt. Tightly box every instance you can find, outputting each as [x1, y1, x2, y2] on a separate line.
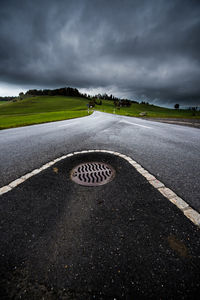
[71, 162, 115, 186]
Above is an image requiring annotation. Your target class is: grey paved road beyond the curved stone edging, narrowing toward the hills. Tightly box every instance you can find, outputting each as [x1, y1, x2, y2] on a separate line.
[0, 112, 200, 212]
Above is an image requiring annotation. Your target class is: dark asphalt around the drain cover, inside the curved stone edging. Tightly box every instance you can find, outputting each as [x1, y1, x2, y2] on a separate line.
[0, 153, 200, 300]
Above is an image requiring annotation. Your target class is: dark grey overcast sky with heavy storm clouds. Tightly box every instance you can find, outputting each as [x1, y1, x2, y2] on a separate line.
[0, 0, 200, 105]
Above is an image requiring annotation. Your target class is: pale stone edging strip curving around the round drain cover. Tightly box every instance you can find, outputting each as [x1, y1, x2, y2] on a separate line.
[0, 150, 200, 227]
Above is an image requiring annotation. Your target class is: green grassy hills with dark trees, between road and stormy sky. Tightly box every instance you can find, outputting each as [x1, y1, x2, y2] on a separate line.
[0, 88, 200, 129]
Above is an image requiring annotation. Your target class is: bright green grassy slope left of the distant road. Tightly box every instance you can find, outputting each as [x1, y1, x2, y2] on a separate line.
[0, 96, 88, 129]
